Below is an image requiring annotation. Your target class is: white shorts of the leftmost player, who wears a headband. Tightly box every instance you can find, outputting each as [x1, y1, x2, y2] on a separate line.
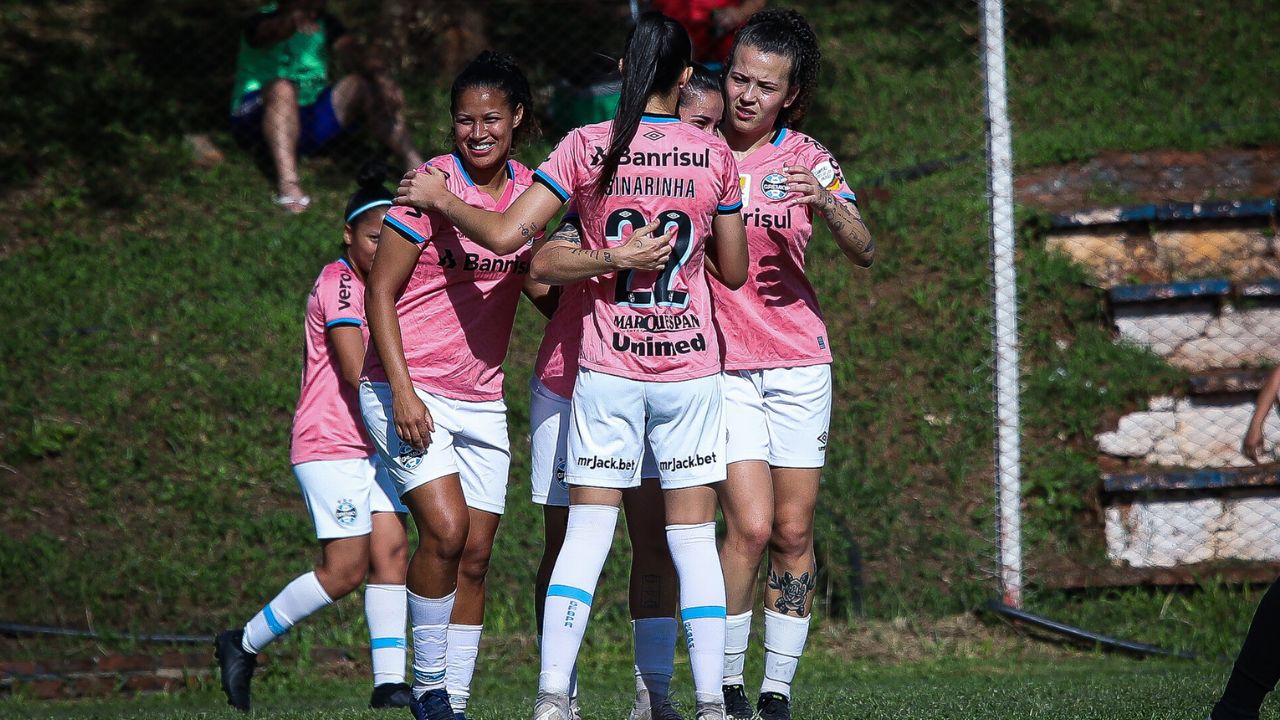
[293, 455, 408, 539]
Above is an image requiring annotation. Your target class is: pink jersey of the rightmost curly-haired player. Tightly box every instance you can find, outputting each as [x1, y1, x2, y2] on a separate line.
[710, 128, 856, 370]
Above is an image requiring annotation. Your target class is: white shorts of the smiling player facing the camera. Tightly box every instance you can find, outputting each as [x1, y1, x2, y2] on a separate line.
[360, 382, 511, 515]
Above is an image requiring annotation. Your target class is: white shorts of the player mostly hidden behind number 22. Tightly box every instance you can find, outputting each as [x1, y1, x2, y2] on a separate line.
[529, 377, 658, 507]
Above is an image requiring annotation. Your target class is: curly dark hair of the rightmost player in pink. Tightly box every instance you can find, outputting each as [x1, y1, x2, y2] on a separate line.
[728, 9, 822, 128]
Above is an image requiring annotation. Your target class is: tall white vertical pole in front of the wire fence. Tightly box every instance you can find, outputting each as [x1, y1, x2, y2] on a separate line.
[980, 0, 1023, 607]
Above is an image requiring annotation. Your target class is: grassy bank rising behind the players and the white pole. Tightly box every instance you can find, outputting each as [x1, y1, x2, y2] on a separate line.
[0, 0, 1280, 681]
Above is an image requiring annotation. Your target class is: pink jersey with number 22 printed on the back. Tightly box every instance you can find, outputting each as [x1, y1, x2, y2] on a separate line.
[535, 115, 742, 382]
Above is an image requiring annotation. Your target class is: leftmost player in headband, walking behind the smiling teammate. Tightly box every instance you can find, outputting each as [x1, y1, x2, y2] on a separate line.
[215, 168, 410, 712]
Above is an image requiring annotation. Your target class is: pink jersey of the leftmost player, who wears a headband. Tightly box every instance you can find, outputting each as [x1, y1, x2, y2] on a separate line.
[289, 259, 374, 465]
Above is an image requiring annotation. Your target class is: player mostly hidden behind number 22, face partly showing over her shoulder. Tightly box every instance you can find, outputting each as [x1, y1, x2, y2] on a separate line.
[529, 65, 724, 720]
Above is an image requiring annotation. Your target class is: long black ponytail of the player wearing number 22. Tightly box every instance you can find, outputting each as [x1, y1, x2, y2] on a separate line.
[595, 12, 692, 195]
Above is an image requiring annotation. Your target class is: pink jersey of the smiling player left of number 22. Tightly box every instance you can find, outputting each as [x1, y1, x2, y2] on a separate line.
[365, 155, 532, 402]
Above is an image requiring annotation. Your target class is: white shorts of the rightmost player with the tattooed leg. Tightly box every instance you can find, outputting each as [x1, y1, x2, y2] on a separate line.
[724, 365, 831, 468]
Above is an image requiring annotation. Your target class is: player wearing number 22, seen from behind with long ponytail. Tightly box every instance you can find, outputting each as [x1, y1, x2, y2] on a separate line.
[397, 13, 746, 720]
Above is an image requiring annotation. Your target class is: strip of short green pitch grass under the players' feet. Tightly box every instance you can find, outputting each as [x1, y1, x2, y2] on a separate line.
[0, 655, 1280, 720]
